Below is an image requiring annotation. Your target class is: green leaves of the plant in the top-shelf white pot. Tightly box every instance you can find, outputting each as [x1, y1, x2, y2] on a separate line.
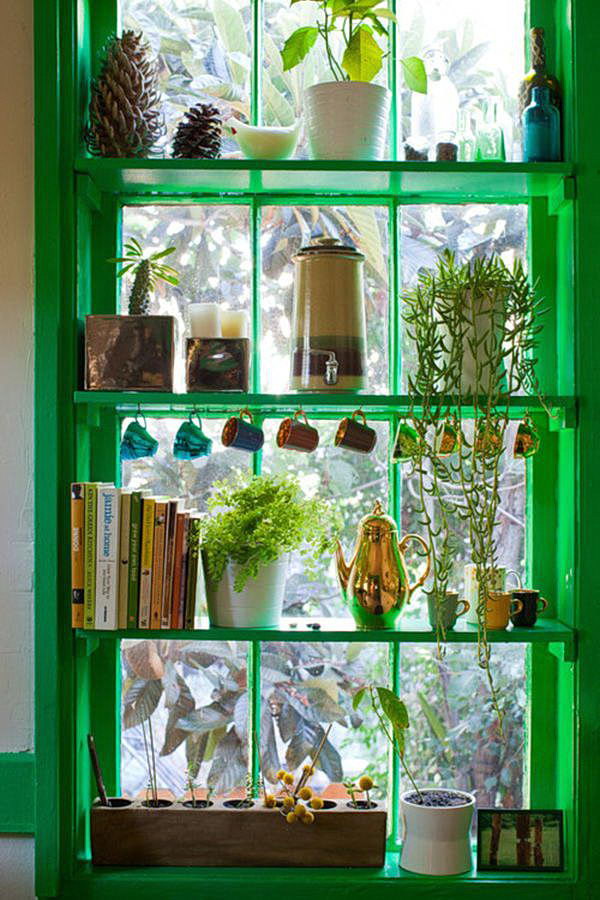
[281, 0, 427, 94]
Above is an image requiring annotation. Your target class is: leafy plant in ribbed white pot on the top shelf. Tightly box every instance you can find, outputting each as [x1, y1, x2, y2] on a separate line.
[281, 0, 427, 159]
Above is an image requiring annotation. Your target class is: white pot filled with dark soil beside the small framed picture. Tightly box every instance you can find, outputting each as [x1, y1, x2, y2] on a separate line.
[400, 788, 475, 875]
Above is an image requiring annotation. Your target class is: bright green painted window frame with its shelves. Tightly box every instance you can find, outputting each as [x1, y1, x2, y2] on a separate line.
[35, 0, 600, 900]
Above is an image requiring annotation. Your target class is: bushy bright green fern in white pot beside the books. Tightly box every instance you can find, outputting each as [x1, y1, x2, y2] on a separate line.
[201, 474, 337, 628]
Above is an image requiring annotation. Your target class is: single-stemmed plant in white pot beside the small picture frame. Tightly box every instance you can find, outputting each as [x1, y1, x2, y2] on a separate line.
[352, 685, 475, 875]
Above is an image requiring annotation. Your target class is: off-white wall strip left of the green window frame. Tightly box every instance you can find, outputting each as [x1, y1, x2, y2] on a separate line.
[0, 0, 34, 900]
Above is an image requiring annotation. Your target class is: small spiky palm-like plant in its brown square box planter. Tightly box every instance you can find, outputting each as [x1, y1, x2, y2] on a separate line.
[85, 238, 178, 392]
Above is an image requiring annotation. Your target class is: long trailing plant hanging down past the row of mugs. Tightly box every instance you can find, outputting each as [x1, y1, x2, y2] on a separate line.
[403, 251, 542, 725]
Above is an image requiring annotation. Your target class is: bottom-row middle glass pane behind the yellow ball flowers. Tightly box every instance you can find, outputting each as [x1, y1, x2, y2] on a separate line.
[261, 642, 389, 800]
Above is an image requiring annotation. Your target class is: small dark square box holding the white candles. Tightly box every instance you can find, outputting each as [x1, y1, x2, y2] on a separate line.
[185, 338, 250, 392]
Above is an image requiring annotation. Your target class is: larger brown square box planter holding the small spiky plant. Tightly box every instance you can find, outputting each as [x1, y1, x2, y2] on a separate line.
[85, 316, 175, 393]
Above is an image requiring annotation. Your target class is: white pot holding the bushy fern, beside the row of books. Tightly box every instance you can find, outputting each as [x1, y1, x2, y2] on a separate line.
[204, 554, 288, 628]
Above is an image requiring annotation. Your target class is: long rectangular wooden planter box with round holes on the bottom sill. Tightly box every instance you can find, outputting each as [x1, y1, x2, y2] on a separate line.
[91, 801, 386, 867]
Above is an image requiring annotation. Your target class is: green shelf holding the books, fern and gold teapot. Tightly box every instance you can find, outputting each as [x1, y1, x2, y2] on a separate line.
[76, 616, 577, 660]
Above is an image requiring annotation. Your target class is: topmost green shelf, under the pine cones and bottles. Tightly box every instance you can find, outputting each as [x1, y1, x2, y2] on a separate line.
[75, 158, 574, 205]
